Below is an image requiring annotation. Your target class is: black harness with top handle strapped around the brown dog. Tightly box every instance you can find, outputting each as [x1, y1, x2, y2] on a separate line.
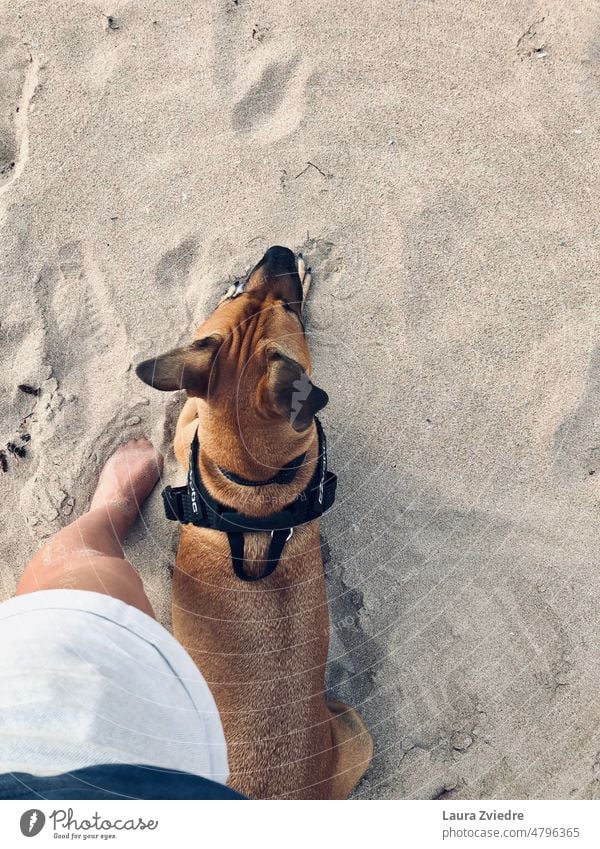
[162, 418, 337, 581]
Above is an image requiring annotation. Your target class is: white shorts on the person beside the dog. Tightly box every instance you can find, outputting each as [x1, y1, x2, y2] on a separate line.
[0, 590, 229, 783]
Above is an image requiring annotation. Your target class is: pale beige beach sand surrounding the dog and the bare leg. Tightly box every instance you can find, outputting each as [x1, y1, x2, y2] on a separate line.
[0, 0, 600, 798]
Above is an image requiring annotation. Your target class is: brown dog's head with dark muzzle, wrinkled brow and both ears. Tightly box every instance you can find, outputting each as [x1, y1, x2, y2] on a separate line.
[136, 247, 328, 436]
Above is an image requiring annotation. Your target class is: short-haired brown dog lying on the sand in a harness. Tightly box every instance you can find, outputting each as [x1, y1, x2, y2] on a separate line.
[137, 247, 372, 799]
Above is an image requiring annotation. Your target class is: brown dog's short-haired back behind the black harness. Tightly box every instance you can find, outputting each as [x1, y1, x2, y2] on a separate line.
[173, 523, 333, 799]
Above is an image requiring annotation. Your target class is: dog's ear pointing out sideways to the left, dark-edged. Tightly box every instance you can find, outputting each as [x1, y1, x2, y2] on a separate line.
[135, 333, 223, 398]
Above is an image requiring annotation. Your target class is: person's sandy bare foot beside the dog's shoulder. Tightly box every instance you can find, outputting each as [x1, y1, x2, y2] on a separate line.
[90, 439, 163, 527]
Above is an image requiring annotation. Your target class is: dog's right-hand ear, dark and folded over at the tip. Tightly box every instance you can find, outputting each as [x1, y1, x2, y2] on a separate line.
[266, 346, 329, 432]
